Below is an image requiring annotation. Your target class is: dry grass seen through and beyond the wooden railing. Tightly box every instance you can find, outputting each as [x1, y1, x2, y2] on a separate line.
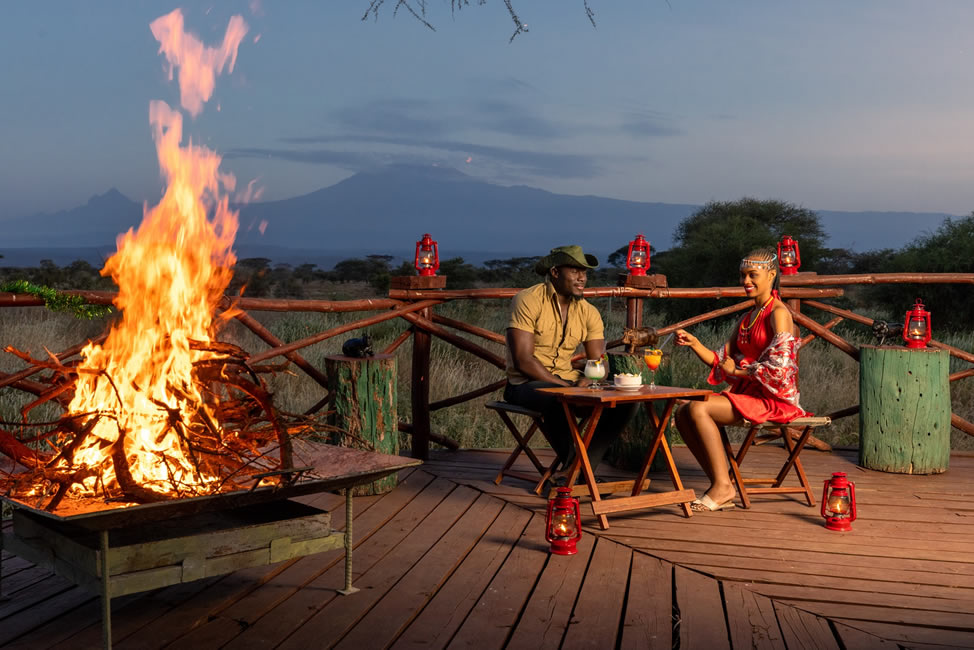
[0, 292, 974, 449]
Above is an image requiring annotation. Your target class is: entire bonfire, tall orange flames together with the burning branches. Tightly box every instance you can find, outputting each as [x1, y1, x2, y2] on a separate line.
[0, 10, 328, 511]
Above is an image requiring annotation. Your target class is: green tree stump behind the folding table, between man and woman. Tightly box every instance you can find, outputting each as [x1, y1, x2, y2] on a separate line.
[605, 352, 680, 472]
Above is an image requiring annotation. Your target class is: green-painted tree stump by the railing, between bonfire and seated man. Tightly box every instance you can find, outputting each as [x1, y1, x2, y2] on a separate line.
[325, 354, 399, 496]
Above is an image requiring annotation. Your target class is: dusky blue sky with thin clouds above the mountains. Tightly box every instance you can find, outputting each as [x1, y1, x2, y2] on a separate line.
[0, 0, 974, 220]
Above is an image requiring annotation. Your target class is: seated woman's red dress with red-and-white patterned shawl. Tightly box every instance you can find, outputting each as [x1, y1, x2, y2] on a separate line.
[707, 306, 808, 424]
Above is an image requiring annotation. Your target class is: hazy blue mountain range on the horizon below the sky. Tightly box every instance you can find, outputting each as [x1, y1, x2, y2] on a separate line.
[0, 165, 952, 268]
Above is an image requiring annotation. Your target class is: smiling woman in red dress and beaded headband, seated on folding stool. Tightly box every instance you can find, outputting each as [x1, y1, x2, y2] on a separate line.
[676, 248, 806, 511]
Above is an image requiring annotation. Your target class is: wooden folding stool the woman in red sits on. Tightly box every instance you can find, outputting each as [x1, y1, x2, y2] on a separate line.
[718, 417, 832, 508]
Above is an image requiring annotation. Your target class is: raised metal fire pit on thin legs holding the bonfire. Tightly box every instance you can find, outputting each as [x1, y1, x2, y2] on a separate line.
[0, 444, 421, 648]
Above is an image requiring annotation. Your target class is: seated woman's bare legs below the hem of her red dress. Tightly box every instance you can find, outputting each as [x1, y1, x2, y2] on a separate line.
[677, 395, 740, 503]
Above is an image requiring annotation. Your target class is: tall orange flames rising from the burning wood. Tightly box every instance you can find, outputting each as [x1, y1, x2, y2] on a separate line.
[62, 10, 247, 494]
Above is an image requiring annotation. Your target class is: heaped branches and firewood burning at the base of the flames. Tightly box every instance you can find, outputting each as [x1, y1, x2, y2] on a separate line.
[0, 341, 334, 512]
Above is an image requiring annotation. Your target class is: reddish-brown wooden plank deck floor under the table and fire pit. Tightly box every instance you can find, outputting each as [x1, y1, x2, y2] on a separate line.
[0, 446, 974, 650]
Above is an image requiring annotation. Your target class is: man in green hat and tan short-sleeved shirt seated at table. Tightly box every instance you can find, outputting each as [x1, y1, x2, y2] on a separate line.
[504, 246, 636, 476]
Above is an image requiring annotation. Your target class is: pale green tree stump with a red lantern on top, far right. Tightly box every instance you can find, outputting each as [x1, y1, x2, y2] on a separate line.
[859, 345, 950, 474]
